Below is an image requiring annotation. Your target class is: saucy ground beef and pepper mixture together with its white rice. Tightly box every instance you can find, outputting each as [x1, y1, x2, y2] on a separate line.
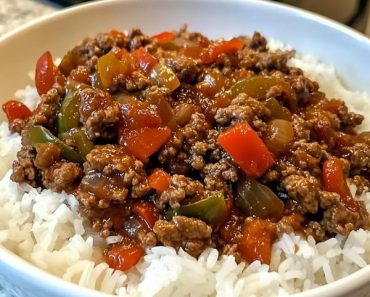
[0, 27, 370, 296]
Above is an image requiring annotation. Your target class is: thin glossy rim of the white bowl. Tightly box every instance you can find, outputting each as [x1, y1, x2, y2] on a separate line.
[0, 0, 370, 297]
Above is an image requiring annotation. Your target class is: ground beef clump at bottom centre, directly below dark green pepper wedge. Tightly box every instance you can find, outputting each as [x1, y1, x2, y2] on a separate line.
[153, 216, 213, 257]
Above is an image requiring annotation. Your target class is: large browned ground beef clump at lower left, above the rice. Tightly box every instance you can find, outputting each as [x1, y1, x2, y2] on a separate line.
[77, 145, 150, 208]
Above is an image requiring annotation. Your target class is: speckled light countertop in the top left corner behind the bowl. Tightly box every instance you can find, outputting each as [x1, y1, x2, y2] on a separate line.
[0, 0, 61, 36]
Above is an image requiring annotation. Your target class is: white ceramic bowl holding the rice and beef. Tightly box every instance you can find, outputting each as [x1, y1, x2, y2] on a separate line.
[0, 0, 370, 297]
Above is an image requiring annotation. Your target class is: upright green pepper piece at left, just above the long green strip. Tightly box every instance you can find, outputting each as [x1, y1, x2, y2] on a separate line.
[58, 92, 80, 134]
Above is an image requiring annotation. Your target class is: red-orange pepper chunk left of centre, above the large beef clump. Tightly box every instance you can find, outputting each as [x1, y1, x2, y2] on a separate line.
[126, 127, 171, 161]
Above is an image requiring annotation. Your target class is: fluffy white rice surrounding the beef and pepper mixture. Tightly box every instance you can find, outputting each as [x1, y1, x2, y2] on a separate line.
[0, 42, 370, 297]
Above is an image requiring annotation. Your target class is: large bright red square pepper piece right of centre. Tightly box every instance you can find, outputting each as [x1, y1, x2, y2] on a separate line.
[217, 122, 274, 178]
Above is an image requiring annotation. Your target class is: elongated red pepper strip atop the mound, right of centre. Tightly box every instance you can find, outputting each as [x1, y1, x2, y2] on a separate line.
[202, 38, 244, 64]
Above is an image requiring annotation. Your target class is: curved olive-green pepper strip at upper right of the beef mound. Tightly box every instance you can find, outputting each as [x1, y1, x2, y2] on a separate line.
[230, 75, 297, 106]
